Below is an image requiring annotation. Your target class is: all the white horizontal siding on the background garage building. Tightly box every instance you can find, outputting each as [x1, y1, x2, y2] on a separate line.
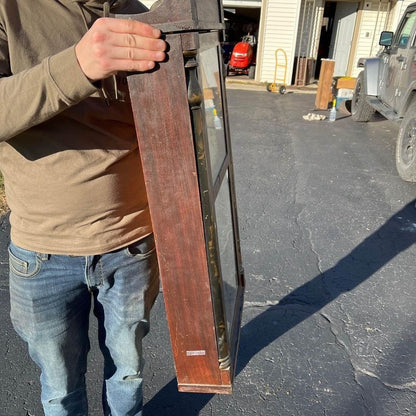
[141, 0, 415, 84]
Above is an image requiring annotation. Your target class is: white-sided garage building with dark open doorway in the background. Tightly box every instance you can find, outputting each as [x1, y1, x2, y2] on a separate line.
[143, 0, 412, 85]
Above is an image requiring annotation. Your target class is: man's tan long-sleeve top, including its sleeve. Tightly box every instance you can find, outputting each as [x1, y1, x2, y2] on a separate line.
[0, 0, 151, 255]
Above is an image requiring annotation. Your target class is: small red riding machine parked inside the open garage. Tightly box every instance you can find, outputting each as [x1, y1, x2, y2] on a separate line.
[227, 34, 256, 79]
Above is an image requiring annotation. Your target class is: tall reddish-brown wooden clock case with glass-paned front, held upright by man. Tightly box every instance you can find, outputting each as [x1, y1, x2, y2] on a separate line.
[116, 0, 244, 393]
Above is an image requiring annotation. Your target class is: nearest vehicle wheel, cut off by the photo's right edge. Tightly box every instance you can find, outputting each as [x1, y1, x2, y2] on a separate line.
[396, 100, 416, 182]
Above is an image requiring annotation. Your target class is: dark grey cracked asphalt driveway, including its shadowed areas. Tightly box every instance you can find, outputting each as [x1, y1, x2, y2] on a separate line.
[0, 89, 416, 416]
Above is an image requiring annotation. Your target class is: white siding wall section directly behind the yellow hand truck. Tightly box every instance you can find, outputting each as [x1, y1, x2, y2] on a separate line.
[258, 0, 301, 84]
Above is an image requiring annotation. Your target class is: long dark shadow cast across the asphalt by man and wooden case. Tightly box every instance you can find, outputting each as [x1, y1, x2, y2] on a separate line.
[145, 200, 416, 416]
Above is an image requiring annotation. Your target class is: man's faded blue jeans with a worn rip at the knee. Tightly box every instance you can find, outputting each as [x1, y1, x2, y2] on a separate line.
[9, 236, 159, 416]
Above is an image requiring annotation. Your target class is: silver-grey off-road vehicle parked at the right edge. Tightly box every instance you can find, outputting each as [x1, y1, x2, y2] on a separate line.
[351, 3, 416, 182]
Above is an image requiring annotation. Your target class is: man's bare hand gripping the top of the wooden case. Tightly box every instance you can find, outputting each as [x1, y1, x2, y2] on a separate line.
[75, 18, 166, 82]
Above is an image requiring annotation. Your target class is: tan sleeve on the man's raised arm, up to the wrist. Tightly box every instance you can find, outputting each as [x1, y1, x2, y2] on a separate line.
[0, 27, 96, 141]
